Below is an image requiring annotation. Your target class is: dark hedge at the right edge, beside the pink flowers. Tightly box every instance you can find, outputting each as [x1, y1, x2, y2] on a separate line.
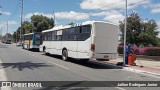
[146, 47, 160, 56]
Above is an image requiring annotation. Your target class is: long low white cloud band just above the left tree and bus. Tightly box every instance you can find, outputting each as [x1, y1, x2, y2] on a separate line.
[24, 11, 89, 20]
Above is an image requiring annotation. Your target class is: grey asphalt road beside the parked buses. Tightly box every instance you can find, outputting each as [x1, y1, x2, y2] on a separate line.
[0, 43, 160, 90]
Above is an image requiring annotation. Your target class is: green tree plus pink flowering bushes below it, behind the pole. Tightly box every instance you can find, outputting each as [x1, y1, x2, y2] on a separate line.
[118, 12, 160, 56]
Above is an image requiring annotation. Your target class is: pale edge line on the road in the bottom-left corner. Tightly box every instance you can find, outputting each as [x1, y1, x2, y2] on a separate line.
[0, 58, 11, 90]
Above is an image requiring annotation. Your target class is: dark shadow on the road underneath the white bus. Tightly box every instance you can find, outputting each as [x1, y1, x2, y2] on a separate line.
[43, 54, 122, 69]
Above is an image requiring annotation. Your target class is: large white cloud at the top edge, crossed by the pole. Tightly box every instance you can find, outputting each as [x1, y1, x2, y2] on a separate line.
[80, 0, 150, 10]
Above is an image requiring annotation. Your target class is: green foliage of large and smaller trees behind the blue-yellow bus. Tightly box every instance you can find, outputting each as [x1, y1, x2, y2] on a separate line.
[13, 15, 54, 40]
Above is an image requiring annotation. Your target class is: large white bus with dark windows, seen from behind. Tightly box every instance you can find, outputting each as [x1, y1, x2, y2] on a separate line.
[40, 21, 118, 60]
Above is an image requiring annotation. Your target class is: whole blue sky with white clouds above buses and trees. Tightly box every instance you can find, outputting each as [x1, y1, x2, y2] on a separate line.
[0, 0, 160, 36]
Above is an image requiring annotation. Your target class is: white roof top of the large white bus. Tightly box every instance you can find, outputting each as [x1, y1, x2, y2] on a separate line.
[42, 21, 116, 32]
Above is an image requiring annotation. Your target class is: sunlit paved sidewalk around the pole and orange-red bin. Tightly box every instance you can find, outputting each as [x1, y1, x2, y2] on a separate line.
[106, 56, 160, 75]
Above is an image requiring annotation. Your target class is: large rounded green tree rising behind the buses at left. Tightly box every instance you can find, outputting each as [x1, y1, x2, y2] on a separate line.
[31, 15, 54, 32]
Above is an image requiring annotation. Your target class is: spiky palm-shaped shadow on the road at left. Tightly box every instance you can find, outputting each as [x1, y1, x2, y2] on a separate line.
[0, 61, 51, 71]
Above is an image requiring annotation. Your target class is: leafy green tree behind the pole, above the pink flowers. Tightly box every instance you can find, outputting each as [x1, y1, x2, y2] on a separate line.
[119, 12, 159, 46]
